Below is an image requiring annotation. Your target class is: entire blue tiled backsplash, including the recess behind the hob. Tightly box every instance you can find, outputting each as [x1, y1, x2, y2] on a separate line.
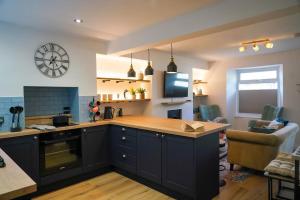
[0, 87, 93, 131]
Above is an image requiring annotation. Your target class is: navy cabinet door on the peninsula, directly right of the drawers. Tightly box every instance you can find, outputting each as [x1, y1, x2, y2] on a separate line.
[137, 130, 162, 184]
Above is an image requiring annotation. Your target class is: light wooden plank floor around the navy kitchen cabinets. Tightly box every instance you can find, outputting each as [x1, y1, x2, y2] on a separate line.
[35, 172, 267, 200]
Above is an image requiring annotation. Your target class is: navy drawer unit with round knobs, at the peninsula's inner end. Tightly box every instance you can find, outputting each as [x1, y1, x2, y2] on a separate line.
[110, 126, 137, 174]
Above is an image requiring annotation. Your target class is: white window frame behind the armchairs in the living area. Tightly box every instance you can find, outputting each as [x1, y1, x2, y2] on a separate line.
[235, 64, 283, 118]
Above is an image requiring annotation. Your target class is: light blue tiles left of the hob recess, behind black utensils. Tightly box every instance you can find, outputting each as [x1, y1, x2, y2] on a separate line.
[0, 97, 25, 131]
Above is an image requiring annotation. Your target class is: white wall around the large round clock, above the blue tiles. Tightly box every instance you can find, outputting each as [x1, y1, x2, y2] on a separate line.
[0, 23, 107, 97]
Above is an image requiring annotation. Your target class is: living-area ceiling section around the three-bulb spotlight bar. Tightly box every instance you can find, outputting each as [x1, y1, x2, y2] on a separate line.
[156, 13, 300, 61]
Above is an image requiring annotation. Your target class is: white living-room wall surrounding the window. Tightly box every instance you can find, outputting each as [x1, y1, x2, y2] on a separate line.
[207, 49, 300, 144]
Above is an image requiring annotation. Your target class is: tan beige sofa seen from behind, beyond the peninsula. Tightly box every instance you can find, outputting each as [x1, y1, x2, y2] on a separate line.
[226, 123, 299, 171]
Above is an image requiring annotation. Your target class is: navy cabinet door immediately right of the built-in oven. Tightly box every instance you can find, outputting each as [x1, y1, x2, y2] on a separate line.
[82, 126, 110, 171]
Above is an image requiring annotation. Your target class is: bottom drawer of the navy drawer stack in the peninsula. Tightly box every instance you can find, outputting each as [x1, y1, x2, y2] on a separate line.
[112, 147, 136, 174]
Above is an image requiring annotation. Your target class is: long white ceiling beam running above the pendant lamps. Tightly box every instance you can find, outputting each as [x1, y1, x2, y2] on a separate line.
[107, 0, 300, 55]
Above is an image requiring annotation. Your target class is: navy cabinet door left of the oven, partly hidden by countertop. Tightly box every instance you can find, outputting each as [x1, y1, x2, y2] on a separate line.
[0, 135, 39, 183]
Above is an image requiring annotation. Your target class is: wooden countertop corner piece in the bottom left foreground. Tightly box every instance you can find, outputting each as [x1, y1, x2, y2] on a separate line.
[0, 149, 37, 200]
